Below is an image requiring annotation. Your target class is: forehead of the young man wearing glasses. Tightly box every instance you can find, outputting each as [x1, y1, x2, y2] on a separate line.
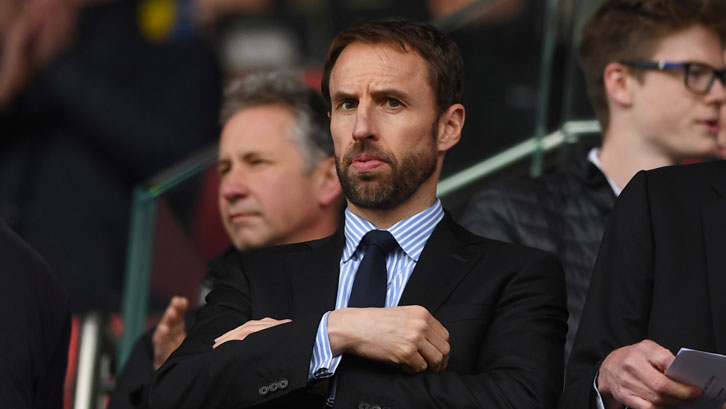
[653, 25, 724, 68]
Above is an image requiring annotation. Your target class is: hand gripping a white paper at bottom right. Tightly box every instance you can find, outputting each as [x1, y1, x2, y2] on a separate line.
[597, 339, 703, 409]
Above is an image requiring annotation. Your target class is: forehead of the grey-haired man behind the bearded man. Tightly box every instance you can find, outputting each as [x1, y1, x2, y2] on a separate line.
[219, 104, 297, 156]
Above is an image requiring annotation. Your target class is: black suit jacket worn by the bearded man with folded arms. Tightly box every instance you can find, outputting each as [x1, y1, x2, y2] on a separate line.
[150, 214, 567, 409]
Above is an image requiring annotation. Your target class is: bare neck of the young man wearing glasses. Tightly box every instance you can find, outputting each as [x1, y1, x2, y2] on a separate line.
[599, 124, 677, 189]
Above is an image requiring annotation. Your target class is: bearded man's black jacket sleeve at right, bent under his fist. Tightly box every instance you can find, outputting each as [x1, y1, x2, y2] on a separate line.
[335, 252, 567, 409]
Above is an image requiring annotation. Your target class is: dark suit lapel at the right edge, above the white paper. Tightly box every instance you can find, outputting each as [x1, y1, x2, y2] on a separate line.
[701, 173, 726, 353]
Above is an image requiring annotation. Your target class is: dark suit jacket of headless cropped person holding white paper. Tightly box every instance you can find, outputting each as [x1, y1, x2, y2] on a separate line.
[561, 161, 726, 409]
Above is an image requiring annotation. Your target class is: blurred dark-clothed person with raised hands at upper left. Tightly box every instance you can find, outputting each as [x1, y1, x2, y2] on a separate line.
[0, 0, 221, 313]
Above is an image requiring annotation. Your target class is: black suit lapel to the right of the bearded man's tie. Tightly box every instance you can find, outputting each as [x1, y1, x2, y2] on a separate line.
[398, 213, 481, 314]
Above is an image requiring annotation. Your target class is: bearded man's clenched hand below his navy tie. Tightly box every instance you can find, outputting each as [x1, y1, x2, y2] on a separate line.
[328, 305, 450, 374]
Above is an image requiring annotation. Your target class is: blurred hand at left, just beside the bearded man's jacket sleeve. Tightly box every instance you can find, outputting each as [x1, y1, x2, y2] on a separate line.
[151, 296, 189, 371]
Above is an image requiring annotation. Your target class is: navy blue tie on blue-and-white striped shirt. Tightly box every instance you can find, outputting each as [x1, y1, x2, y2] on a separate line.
[348, 230, 398, 308]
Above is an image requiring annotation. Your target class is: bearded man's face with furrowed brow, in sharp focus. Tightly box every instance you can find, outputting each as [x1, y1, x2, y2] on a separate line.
[330, 43, 443, 209]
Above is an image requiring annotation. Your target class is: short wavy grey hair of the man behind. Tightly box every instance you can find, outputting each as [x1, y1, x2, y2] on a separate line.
[222, 71, 334, 172]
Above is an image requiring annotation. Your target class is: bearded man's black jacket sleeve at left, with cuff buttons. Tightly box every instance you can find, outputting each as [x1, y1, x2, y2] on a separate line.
[149, 255, 321, 409]
